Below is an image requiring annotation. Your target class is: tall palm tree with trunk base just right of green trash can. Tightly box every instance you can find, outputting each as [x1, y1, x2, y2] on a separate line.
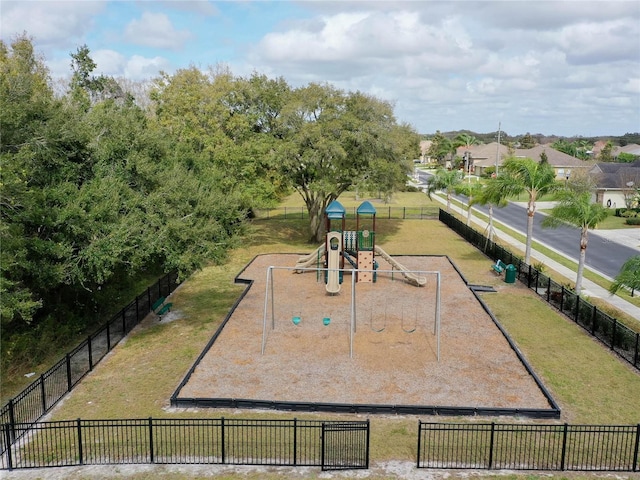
[492, 157, 558, 264]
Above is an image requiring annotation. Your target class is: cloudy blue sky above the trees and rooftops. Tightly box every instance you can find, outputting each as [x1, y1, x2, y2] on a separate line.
[0, 0, 640, 136]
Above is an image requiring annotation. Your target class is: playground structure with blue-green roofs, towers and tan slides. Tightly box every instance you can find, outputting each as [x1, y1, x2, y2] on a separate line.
[294, 200, 427, 295]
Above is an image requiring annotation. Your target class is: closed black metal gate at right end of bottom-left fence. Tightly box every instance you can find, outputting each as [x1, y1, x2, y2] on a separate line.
[322, 420, 369, 470]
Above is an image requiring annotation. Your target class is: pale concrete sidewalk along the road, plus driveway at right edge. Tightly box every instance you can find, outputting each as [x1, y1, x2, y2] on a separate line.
[432, 195, 640, 322]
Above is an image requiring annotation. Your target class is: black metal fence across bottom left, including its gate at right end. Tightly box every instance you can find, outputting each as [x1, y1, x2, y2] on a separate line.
[0, 418, 369, 470]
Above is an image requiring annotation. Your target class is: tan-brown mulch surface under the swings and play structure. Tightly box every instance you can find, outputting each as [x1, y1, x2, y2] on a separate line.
[179, 254, 550, 409]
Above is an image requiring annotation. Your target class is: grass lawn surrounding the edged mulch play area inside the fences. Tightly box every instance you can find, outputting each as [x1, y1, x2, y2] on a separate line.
[6, 194, 640, 480]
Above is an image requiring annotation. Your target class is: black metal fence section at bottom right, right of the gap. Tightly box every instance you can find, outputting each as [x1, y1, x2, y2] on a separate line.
[417, 422, 640, 472]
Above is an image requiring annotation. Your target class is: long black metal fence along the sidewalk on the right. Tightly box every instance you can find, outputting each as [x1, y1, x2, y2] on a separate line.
[439, 210, 640, 369]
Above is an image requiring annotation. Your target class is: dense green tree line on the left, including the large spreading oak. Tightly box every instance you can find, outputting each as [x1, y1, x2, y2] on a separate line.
[0, 35, 419, 365]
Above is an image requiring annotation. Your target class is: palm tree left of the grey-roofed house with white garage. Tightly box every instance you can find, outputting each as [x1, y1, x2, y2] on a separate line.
[542, 189, 608, 295]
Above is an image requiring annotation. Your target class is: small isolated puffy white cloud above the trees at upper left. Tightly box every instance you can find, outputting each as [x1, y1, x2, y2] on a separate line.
[124, 12, 193, 50]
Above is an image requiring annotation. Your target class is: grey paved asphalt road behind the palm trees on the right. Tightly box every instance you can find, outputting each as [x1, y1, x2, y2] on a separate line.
[417, 171, 640, 279]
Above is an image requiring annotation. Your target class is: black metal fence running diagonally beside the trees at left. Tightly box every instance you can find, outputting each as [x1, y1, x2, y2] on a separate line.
[0, 272, 178, 452]
